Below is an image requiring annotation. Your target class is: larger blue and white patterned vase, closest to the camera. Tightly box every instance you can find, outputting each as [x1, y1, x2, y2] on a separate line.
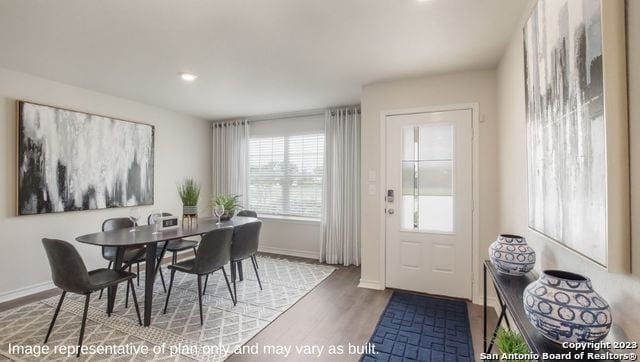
[523, 270, 612, 343]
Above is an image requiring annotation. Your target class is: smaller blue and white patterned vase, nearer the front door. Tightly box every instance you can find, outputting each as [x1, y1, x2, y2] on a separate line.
[489, 234, 536, 275]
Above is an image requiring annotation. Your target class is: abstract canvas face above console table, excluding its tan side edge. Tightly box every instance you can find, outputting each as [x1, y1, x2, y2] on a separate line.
[524, 0, 607, 265]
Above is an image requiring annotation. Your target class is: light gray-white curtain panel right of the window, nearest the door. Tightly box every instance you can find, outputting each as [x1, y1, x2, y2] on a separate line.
[320, 108, 360, 265]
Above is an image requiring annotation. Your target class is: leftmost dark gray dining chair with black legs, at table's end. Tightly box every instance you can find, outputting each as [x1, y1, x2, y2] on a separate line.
[42, 239, 142, 357]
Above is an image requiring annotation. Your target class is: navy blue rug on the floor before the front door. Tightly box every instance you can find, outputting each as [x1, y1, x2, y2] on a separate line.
[360, 292, 474, 362]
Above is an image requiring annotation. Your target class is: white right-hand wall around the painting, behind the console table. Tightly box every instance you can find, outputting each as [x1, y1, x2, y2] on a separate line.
[498, 1, 640, 341]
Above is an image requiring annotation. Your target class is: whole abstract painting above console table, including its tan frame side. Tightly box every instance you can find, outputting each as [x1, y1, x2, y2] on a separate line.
[524, 0, 630, 271]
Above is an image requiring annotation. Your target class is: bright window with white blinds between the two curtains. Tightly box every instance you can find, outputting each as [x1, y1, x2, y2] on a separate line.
[249, 116, 324, 219]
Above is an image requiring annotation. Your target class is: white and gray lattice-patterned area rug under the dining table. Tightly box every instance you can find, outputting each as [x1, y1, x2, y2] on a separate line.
[0, 256, 335, 361]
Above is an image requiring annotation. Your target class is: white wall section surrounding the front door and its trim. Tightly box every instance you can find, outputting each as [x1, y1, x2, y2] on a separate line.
[361, 70, 498, 302]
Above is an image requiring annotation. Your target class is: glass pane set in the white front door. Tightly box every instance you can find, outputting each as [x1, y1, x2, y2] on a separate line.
[399, 123, 454, 232]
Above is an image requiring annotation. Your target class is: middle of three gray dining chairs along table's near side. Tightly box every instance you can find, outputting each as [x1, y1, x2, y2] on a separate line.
[162, 226, 236, 325]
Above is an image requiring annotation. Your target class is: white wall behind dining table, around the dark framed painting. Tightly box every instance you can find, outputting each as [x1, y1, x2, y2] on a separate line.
[0, 68, 211, 301]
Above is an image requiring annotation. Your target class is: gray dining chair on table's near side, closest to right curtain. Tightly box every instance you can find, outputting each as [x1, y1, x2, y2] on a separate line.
[231, 220, 262, 300]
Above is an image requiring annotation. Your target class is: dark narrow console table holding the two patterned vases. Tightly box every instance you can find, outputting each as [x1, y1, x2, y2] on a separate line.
[483, 260, 612, 361]
